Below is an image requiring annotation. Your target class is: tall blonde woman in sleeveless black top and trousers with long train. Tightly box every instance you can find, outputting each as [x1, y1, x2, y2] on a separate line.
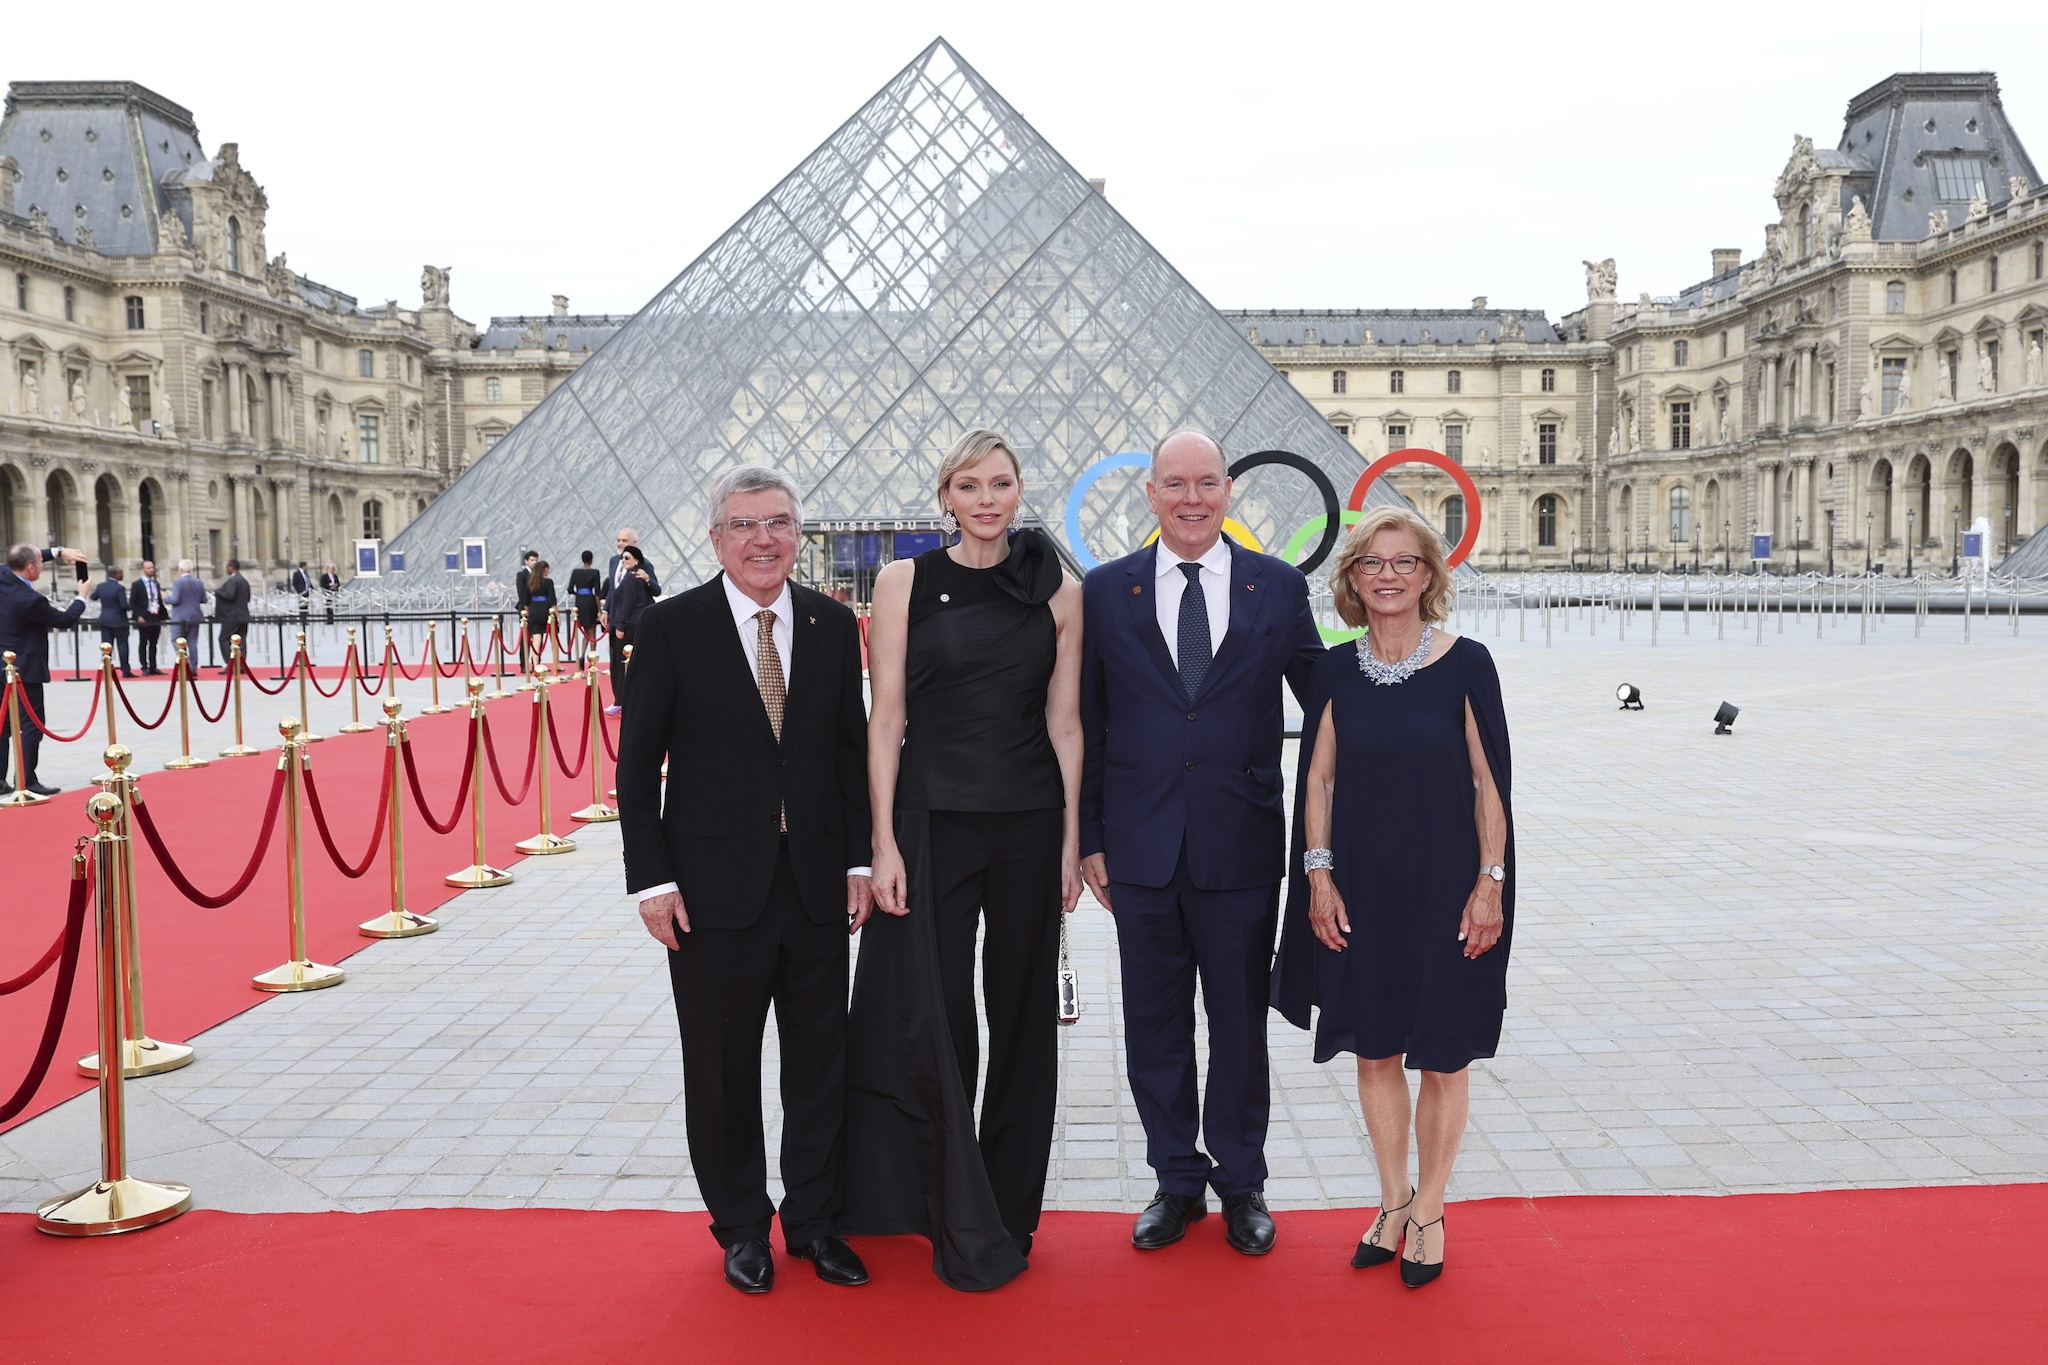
[846, 430, 1081, 1289]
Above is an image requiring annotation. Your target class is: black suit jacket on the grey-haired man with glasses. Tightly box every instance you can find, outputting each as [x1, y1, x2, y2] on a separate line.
[618, 579, 874, 929]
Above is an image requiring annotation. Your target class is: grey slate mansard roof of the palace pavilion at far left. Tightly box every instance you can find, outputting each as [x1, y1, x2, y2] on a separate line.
[0, 80, 207, 256]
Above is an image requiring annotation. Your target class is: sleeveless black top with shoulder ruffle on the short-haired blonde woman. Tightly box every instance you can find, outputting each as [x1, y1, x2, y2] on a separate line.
[897, 530, 1067, 810]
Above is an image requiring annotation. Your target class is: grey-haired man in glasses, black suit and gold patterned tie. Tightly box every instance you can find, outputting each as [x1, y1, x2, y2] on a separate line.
[618, 465, 872, 1293]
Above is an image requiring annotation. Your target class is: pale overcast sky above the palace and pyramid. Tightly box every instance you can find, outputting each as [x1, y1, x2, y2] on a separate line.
[0, 0, 2048, 323]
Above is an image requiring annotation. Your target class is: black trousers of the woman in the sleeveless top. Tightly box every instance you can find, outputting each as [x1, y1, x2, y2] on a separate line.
[911, 810, 1063, 1238]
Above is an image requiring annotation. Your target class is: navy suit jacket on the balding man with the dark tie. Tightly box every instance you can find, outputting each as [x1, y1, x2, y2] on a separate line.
[1081, 542, 1323, 890]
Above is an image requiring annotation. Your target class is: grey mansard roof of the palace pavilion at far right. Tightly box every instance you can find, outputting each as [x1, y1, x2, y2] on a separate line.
[1843, 72, 2040, 241]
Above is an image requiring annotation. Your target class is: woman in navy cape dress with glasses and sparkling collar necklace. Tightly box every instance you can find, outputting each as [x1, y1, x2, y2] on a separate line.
[1274, 508, 1516, 1287]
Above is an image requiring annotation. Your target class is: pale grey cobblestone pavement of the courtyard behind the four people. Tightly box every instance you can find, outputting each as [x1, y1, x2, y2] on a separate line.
[0, 612, 2048, 1209]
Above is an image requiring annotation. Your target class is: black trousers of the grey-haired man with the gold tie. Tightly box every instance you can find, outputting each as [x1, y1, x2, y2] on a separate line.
[668, 845, 848, 1246]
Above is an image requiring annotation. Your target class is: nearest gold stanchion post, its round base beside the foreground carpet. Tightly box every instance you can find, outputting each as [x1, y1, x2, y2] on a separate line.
[35, 792, 193, 1236]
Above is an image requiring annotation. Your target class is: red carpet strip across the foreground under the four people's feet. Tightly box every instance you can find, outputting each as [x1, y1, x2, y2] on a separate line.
[0, 1186, 2048, 1365]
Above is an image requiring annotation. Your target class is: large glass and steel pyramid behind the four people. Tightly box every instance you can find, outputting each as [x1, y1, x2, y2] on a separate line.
[391, 39, 1403, 591]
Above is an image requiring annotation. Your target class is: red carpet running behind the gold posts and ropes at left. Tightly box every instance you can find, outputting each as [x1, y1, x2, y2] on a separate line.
[0, 684, 627, 1130]
